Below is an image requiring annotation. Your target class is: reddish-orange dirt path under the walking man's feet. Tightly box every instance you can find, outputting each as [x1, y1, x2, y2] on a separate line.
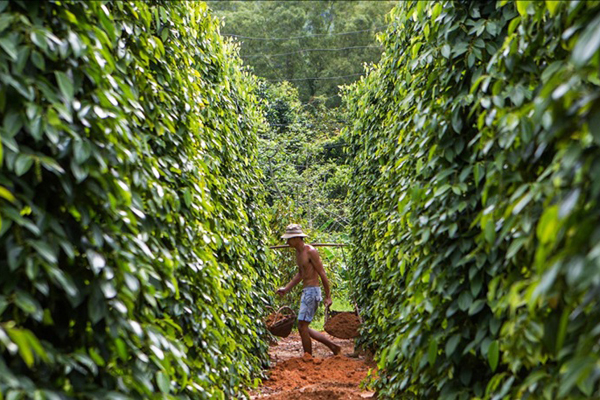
[251, 332, 374, 400]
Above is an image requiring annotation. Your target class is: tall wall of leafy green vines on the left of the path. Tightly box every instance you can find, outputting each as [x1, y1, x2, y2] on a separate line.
[0, 1, 271, 399]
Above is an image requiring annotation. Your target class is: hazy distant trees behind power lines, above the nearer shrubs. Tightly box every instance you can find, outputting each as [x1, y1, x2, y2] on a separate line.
[209, 0, 394, 106]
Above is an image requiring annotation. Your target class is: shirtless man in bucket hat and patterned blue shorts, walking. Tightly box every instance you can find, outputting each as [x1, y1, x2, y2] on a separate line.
[276, 224, 341, 356]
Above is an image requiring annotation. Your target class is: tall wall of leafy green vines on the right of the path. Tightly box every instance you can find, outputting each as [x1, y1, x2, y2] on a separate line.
[346, 0, 600, 399]
